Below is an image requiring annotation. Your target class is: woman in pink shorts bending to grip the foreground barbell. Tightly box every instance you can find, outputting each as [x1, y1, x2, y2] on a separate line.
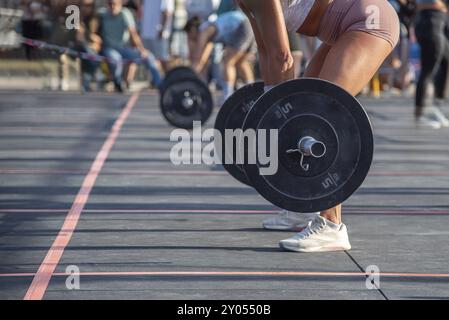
[236, 0, 399, 252]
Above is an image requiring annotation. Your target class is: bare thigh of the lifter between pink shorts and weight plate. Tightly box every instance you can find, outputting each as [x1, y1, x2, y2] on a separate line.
[319, 31, 393, 96]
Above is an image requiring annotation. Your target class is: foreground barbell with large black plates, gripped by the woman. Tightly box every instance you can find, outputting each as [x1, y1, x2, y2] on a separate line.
[215, 78, 374, 212]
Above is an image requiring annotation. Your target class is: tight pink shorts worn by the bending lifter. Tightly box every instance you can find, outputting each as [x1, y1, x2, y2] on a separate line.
[318, 0, 399, 48]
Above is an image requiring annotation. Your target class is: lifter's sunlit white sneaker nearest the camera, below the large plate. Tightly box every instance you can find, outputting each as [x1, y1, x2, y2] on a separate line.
[279, 216, 351, 252]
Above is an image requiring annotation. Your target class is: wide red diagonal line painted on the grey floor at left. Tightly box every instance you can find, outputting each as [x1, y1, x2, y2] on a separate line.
[24, 94, 139, 300]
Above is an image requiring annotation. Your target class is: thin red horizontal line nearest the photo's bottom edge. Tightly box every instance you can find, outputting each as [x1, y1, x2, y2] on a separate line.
[0, 271, 449, 278]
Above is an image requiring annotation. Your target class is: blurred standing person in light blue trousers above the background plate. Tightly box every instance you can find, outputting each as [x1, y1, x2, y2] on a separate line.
[141, 0, 175, 72]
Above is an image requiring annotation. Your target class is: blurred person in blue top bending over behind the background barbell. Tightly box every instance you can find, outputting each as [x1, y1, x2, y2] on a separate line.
[185, 11, 255, 99]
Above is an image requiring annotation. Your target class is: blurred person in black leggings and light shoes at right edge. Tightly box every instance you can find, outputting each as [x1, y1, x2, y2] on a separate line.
[415, 0, 449, 129]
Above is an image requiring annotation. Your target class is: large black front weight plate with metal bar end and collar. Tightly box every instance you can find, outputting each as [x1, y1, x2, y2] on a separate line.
[243, 79, 374, 212]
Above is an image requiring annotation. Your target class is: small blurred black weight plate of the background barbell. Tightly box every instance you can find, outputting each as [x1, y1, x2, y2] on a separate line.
[160, 78, 214, 129]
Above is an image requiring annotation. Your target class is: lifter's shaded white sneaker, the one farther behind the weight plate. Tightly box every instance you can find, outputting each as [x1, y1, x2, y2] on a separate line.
[263, 210, 320, 231]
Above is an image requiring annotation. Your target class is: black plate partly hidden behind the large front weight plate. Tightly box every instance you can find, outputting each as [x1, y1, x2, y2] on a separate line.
[215, 82, 264, 185]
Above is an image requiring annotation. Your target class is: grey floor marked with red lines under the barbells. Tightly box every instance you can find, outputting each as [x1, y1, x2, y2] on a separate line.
[0, 91, 449, 300]
